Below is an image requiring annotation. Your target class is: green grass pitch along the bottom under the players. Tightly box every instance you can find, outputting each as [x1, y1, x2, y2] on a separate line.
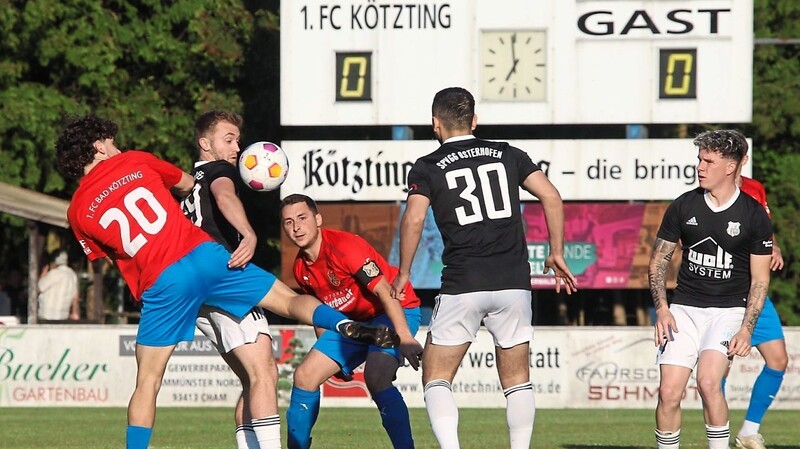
[0, 408, 800, 449]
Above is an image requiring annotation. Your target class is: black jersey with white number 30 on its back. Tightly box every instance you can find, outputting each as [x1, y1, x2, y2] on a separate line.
[408, 136, 539, 294]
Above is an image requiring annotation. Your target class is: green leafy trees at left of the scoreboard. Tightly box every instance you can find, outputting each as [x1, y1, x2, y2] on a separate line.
[0, 0, 279, 316]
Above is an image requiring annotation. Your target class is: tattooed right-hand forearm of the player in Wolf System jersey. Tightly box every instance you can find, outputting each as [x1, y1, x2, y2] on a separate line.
[728, 254, 772, 357]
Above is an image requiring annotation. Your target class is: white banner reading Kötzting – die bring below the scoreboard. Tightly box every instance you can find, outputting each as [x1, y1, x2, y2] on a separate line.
[281, 138, 753, 202]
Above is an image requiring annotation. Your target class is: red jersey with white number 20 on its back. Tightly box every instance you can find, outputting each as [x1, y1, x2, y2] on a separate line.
[67, 151, 212, 298]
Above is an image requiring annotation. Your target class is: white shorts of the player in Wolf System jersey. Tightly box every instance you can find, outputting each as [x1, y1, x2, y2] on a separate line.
[656, 304, 744, 369]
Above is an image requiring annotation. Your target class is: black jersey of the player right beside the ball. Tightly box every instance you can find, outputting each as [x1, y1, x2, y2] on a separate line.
[182, 161, 241, 251]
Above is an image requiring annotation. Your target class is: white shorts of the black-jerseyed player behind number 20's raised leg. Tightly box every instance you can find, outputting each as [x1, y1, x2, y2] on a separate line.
[196, 306, 271, 354]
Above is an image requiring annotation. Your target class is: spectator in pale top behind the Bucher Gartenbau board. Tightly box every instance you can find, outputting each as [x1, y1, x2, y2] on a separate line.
[37, 251, 80, 321]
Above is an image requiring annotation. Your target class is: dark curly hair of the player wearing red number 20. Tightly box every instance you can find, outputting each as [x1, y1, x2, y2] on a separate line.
[56, 114, 117, 179]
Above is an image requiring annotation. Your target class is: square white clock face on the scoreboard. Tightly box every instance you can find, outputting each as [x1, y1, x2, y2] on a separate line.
[480, 30, 547, 101]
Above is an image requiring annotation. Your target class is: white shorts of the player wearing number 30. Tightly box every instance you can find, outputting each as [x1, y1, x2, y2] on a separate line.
[428, 290, 533, 349]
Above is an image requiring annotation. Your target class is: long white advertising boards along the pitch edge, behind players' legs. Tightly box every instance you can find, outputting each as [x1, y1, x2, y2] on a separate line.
[0, 325, 800, 410]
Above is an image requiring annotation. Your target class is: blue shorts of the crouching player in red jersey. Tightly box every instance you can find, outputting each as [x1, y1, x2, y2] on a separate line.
[311, 307, 421, 375]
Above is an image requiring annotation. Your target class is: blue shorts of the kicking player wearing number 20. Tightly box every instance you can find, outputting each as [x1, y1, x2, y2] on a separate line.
[136, 242, 275, 346]
